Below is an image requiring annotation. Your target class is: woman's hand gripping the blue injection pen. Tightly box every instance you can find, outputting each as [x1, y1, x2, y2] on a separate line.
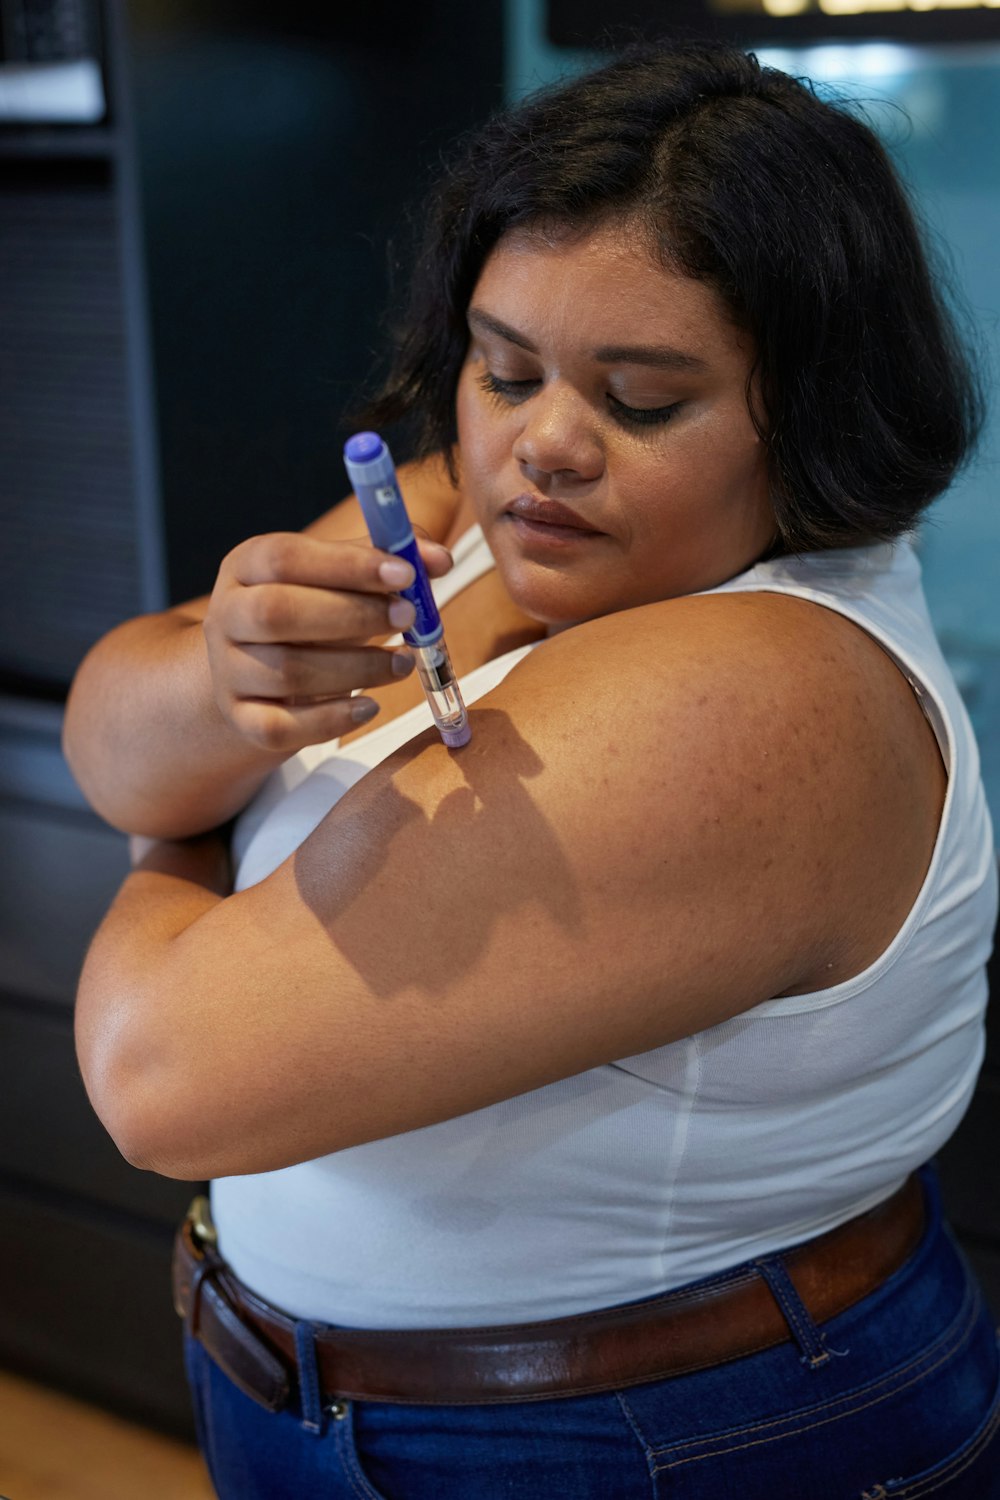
[202, 531, 451, 755]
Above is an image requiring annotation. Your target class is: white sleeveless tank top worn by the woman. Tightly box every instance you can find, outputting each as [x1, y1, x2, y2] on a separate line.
[213, 528, 997, 1328]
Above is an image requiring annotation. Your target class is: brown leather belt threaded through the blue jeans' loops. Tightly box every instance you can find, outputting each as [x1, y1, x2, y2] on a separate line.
[174, 1176, 924, 1410]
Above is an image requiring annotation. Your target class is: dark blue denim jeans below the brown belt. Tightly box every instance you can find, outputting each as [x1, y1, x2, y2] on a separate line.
[187, 1173, 1000, 1500]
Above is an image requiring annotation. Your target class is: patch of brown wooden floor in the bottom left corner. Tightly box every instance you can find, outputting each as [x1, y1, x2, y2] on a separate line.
[0, 1373, 214, 1500]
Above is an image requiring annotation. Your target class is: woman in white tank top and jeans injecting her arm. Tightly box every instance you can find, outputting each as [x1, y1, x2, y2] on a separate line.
[67, 47, 1000, 1500]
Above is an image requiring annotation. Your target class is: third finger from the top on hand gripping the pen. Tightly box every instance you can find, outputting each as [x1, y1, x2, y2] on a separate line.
[228, 644, 414, 702]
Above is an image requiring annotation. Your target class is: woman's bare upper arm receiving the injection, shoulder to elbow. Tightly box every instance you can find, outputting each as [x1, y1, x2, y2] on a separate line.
[97, 602, 941, 1175]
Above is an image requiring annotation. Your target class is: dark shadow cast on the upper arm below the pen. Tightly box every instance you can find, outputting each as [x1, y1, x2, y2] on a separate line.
[294, 708, 582, 998]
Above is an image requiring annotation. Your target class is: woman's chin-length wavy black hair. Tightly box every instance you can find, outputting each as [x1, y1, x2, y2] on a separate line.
[367, 42, 982, 552]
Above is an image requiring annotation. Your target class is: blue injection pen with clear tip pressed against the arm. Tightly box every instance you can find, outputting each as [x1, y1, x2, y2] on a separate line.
[343, 432, 472, 749]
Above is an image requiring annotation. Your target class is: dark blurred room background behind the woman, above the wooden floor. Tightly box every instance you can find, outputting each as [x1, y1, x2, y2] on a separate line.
[0, 0, 1000, 1436]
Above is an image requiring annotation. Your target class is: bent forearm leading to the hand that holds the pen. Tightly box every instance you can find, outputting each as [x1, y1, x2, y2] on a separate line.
[63, 611, 288, 839]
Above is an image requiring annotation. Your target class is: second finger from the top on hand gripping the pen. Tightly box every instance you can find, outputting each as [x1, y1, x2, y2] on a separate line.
[220, 584, 414, 644]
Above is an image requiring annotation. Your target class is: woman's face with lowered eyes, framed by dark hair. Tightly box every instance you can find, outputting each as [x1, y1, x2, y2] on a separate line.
[457, 227, 775, 624]
